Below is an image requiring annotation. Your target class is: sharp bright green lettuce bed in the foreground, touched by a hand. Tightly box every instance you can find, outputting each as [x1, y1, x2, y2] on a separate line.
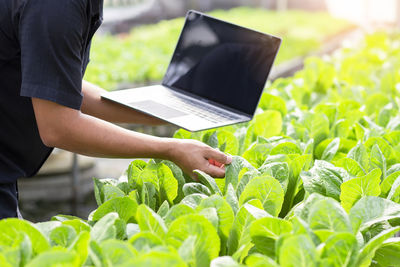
[0, 33, 400, 267]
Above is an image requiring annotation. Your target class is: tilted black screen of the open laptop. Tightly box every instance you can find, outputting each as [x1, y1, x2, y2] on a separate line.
[163, 11, 281, 116]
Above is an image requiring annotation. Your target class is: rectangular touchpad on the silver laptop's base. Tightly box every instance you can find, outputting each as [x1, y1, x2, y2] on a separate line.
[129, 100, 188, 118]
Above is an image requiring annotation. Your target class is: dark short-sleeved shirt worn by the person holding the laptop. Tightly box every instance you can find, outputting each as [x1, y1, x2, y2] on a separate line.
[0, 0, 103, 184]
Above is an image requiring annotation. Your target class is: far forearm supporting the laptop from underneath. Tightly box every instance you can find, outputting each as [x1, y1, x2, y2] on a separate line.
[82, 81, 165, 125]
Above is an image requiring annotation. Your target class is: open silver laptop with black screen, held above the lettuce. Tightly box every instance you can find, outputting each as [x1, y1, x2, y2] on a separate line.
[102, 10, 281, 132]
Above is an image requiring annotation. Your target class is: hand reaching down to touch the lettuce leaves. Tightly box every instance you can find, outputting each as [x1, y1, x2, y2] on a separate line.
[170, 139, 232, 180]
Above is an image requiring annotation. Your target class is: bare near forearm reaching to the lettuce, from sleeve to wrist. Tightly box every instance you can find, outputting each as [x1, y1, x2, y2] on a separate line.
[33, 99, 173, 159]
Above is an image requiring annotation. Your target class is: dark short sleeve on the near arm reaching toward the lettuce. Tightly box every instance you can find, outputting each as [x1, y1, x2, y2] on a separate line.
[19, 0, 87, 109]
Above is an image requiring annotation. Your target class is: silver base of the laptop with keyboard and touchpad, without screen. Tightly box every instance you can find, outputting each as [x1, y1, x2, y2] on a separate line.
[102, 85, 251, 132]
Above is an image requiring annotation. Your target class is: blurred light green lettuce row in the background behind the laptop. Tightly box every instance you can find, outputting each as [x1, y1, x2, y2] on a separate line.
[85, 7, 351, 90]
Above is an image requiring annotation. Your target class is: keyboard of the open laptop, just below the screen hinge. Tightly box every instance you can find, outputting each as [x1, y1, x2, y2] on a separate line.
[163, 94, 238, 123]
